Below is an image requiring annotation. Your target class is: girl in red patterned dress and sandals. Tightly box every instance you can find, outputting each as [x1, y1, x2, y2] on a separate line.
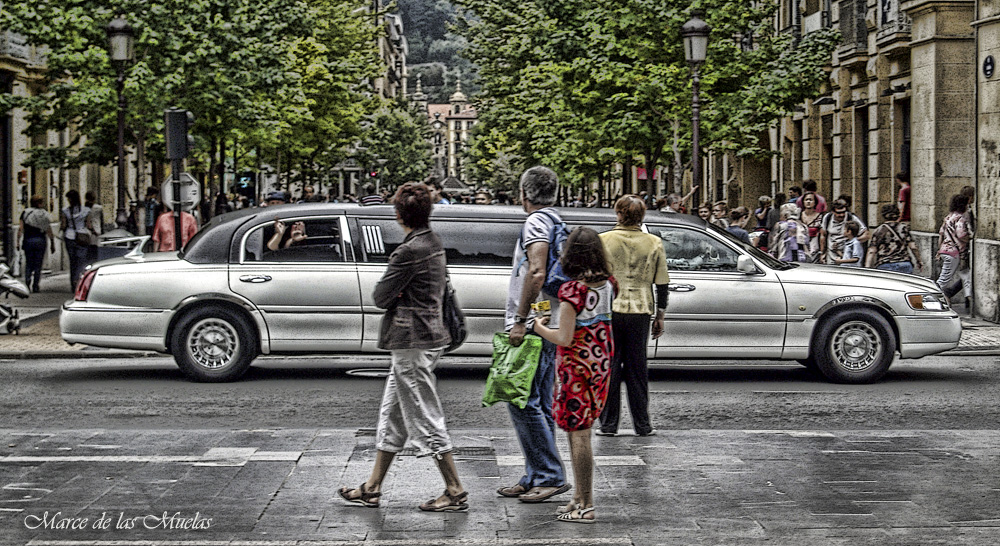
[534, 228, 617, 523]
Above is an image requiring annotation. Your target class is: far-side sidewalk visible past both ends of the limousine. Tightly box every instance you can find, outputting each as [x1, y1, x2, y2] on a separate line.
[0, 273, 1000, 359]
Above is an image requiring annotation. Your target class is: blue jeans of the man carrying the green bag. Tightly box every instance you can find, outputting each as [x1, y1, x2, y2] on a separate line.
[507, 340, 566, 489]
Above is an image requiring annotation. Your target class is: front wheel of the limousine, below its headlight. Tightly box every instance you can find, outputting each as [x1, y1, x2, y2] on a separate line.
[812, 309, 896, 383]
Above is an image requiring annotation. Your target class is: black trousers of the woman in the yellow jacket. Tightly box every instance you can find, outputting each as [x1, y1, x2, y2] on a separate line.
[601, 313, 653, 434]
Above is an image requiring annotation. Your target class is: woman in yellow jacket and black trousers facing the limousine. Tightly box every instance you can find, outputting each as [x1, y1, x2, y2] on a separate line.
[597, 195, 670, 436]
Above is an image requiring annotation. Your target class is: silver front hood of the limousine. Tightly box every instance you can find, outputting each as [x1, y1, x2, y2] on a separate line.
[777, 263, 940, 292]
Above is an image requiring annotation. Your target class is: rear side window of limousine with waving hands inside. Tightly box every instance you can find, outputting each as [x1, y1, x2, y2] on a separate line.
[244, 218, 344, 262]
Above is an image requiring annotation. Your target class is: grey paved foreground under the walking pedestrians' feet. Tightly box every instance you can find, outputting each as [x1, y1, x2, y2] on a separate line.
[0, 428, 1000, 546]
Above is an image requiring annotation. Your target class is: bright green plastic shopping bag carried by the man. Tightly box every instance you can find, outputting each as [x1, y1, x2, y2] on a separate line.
[483, 332, 542, 409]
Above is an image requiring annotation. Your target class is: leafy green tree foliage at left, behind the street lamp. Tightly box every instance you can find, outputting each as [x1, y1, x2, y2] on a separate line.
[0, 0, 379, 198]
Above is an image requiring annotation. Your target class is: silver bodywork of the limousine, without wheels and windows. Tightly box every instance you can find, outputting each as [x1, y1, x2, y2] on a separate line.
[60, 205, 961, 370]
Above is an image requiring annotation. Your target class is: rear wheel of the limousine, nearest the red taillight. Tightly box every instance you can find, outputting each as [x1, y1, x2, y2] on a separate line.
[170, 305, 259, 383]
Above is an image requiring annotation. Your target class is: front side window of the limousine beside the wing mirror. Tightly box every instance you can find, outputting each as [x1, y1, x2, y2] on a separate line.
[648, 225, 739, 271]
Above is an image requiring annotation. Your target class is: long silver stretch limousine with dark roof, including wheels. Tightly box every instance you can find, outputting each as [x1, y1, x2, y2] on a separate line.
[59, 203, 962, 383]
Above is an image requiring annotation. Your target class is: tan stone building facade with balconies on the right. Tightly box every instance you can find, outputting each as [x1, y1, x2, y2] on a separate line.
[772, 0, 1000, 321]
